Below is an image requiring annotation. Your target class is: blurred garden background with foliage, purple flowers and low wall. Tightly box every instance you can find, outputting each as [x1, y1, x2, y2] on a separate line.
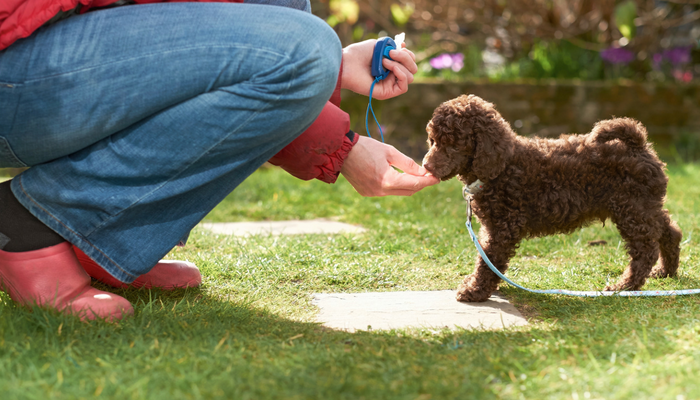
[311, 0, 700, 162]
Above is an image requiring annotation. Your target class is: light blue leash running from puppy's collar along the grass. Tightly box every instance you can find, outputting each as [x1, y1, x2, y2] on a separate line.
[462, 186, 700, 297]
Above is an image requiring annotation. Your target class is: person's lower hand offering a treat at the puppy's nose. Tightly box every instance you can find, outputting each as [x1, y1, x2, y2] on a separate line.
[340, 136, 440, 197]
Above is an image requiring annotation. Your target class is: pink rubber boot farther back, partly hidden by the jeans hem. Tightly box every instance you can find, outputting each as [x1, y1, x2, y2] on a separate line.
[73, 246, 202, 290]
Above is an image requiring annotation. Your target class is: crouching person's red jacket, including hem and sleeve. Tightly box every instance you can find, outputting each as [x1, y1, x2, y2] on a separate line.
[0, 0, 358, 183]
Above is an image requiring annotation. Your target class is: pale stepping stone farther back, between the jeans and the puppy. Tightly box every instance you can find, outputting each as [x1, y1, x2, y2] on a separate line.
[199, 219, 365, 236]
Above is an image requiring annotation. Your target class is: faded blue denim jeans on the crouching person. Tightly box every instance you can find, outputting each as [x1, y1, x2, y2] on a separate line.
[0, 0, 341, 282]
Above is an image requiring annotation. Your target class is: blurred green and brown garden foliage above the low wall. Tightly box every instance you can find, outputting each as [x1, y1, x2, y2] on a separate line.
[317, 0, 700, 84]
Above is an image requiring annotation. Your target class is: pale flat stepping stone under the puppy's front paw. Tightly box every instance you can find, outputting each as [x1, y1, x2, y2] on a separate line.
[313, 290, 527, 332]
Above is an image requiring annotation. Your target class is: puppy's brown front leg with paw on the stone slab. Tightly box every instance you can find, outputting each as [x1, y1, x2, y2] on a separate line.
[457, 225, 520, 302]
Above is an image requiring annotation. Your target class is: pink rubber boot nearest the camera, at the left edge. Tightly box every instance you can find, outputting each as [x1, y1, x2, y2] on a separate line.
[0, 242, 134, 321]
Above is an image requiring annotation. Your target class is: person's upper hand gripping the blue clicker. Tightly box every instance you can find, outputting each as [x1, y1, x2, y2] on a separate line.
[340, 39, 418, 100]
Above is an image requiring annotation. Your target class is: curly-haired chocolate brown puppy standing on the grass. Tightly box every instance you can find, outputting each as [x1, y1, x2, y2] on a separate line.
[423, 96, 682, 301]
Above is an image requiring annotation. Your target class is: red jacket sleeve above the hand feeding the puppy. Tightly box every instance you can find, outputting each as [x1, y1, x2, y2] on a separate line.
[270, 64, 359, 183]
